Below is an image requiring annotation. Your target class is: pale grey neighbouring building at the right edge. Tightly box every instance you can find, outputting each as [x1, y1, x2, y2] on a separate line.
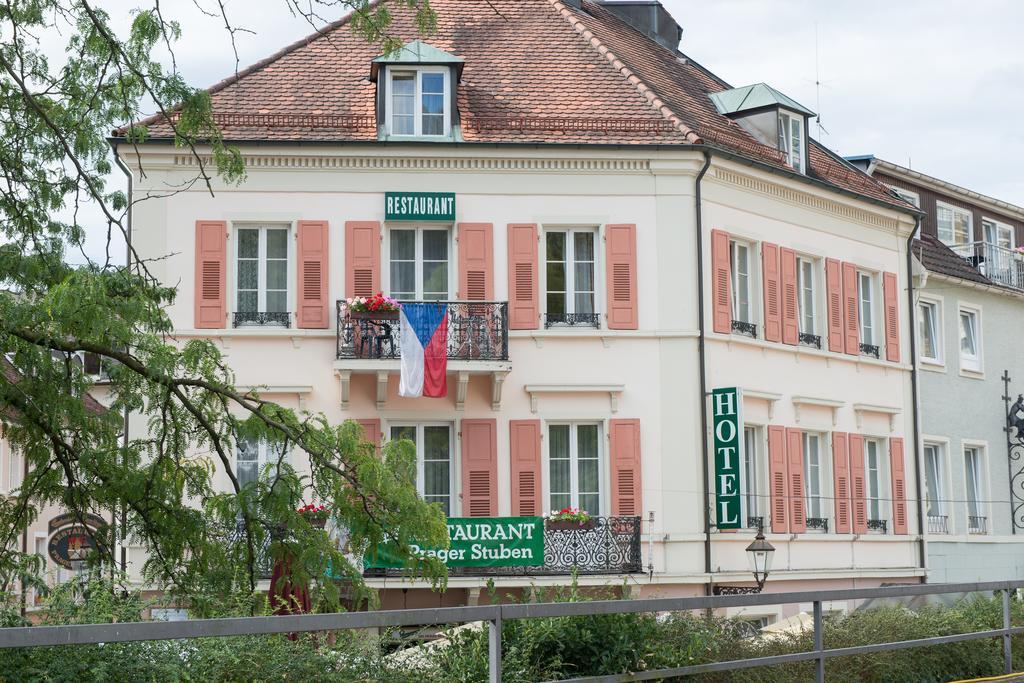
[851, 157, 1024, 582]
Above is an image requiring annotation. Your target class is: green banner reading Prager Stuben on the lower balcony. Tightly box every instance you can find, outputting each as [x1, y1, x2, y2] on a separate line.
[364, 517, 544, 569]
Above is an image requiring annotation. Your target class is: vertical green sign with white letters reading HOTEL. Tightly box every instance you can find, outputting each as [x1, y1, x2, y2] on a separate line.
[711, 387, 743, 529]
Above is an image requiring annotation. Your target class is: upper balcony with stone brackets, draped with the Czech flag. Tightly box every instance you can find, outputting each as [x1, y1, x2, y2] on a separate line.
[334, 301, 512, 410]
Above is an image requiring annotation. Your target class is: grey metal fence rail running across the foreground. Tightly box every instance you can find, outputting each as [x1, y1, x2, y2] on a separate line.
[0, 581, 1024, 683]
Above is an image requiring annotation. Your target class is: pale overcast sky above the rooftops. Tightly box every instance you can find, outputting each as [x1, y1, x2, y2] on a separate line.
[66, 0, 1024, 262]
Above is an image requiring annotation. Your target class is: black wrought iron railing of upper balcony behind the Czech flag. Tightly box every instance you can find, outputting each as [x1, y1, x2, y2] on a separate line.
[337, 301, 509, 360]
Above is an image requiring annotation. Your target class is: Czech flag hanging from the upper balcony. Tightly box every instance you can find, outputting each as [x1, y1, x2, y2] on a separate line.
[398, 303, 447, 398]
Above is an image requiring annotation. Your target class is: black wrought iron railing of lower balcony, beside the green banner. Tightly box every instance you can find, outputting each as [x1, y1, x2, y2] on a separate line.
[362, 517, 643, 577]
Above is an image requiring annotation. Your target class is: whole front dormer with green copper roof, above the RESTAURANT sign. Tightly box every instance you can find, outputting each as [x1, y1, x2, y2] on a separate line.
[370, 40, 464, 141]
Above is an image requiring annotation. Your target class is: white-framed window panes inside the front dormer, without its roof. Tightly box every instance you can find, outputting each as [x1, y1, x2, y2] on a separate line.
[387, 67, 452, 136]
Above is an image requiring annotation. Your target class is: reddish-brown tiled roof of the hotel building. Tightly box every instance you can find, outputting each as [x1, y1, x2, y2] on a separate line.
[115, 0, 912, 210]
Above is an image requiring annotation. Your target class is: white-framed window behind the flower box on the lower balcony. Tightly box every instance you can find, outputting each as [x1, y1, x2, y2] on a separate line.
[548, 422, 603, 516]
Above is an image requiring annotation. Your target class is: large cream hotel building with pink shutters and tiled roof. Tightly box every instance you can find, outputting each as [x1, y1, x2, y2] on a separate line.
[105, 0, 925, 616]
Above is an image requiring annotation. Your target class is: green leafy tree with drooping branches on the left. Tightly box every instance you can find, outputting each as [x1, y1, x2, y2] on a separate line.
[0, 0, 445, 606]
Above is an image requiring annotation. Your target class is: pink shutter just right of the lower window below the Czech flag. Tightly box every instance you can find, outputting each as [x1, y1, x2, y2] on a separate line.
[462, 418, 498, 517]
